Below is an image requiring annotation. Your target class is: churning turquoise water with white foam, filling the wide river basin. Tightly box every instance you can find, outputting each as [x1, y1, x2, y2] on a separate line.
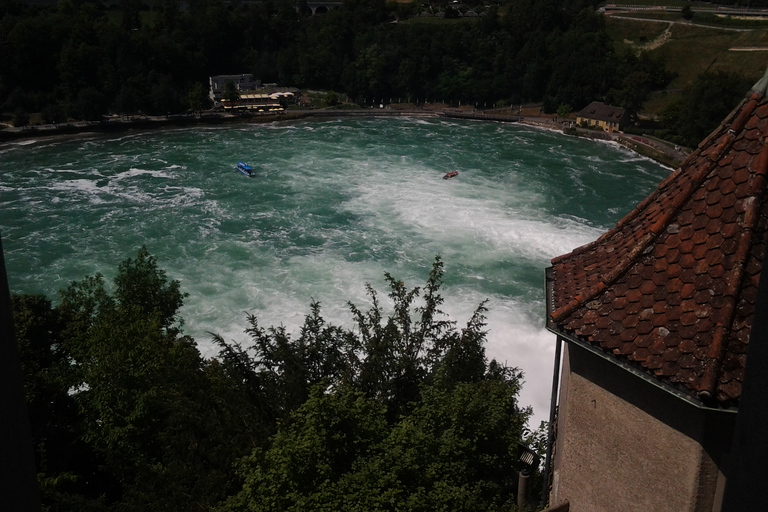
[0, 119, 669, 421]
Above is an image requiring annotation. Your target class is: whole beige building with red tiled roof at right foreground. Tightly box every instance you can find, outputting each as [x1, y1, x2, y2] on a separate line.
[547, 74, 768, 512]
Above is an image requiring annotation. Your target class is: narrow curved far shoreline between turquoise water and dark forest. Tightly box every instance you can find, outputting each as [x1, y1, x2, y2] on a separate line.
[0, 108, 686, 169]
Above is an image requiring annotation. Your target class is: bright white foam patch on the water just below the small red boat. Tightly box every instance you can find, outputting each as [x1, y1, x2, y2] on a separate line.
[345, 157, 601, 266]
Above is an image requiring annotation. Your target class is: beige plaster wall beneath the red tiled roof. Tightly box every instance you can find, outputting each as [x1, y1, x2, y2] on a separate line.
[551, 344, 731, 512]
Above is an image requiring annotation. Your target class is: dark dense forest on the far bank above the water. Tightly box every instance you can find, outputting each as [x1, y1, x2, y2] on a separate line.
[0, 0, 669, 122]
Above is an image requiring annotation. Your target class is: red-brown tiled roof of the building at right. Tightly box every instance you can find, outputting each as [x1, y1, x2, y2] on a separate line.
[547, 81, 768, 407]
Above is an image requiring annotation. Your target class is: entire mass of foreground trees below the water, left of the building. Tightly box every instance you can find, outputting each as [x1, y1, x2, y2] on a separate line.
[13, 249, 541, 511]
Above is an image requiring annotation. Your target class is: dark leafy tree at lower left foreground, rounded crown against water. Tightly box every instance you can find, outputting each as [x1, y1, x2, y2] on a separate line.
[14, 248, 259, 511]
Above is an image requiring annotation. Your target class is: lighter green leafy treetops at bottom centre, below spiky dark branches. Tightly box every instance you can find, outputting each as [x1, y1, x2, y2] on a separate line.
[221, 344, 530, 512]
